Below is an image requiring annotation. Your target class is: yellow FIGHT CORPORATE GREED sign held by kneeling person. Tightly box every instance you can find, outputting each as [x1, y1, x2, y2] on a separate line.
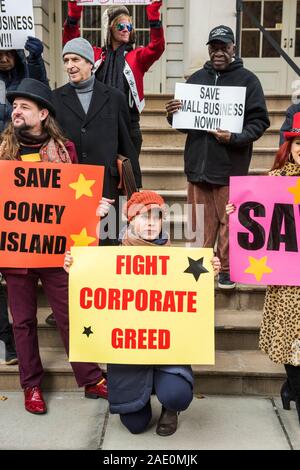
[69, 247, 215, 365]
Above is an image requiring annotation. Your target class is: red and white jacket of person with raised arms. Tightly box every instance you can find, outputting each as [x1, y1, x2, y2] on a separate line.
[63, 2, 165, 113]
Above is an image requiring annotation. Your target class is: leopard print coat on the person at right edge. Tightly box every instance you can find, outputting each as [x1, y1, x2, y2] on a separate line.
[259, 162, 300, 367]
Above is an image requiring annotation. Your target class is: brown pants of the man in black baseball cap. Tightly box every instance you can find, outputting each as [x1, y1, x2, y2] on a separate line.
[188, 183, 229, 272]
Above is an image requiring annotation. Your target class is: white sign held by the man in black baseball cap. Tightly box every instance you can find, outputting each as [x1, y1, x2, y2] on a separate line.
[173, 83, 246, 134]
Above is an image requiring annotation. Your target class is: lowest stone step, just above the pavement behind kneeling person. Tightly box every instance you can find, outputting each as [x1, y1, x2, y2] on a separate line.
[0, 348, 284, 396]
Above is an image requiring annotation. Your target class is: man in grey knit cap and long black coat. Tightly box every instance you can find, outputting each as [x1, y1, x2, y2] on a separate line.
[53, 38, 141, 229]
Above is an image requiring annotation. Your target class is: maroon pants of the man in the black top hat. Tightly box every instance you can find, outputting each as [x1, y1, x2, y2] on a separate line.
[5, 268, 102, 388]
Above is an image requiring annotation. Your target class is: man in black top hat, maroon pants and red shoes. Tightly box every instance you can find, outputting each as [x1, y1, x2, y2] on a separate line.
[0, 78, 107, 414]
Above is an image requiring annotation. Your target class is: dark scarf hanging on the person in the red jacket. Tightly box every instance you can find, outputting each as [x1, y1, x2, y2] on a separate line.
[97, 44, 132, 93]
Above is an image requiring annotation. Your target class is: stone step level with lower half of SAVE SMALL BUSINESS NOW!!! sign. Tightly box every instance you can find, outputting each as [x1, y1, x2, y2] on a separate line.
[141, 108, 286, 128]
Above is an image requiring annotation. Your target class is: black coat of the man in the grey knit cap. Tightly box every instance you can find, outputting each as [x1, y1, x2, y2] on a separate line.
[53, 80, 141, 199]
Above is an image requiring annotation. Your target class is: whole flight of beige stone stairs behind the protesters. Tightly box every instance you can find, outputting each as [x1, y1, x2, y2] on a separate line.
[0, 95, 290, 396]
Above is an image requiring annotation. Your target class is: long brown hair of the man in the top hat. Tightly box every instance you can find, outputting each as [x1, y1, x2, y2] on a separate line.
[0, 112, 68, 160]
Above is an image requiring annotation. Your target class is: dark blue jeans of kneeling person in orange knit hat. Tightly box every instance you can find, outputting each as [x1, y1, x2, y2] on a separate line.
[120, 370, 193, 434]
